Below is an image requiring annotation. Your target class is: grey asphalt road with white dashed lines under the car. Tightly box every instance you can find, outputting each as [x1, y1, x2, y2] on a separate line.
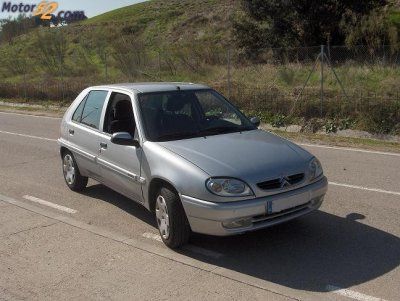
[0, 112, 400, 301]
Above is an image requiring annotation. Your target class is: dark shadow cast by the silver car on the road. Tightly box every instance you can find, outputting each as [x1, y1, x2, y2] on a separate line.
[79, 185, 400, 292]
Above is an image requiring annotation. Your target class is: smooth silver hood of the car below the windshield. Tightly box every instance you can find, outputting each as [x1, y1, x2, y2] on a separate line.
[159, 130, 313, 184]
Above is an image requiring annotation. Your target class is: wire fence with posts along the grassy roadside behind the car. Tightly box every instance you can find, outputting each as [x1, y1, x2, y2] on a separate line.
[0, 44, 400, 131]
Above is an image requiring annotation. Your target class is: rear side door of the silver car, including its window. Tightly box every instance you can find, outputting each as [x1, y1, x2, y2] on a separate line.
[67, 90, 110, 180]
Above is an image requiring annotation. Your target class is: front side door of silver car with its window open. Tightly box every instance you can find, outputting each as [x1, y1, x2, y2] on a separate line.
[98, 92, 144, 203]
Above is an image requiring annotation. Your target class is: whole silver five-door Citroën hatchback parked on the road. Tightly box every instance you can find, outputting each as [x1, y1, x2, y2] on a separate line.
[58, 83, 327, 248]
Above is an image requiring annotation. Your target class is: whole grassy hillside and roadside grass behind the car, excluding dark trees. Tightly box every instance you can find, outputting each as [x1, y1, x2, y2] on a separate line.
[0, 0, 400, 133]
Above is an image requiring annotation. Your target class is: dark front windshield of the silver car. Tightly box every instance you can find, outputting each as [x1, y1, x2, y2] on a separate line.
[139, 90, 256, 141]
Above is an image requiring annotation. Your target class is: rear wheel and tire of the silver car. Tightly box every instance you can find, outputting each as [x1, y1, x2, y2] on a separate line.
[62, 151, 88, 192]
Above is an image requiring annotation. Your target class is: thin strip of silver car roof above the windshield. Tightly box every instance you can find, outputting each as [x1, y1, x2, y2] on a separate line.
[90, 82, 210, 93]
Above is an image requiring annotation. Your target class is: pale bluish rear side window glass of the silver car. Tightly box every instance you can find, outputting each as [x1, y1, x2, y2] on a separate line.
[74, 91, 108, 129]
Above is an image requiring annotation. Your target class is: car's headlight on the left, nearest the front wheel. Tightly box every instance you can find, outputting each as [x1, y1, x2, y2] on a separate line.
[206, 178, 253, 197]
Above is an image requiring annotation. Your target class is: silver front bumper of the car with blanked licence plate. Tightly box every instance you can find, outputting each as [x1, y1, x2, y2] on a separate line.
[181, 177, 328, 236]
